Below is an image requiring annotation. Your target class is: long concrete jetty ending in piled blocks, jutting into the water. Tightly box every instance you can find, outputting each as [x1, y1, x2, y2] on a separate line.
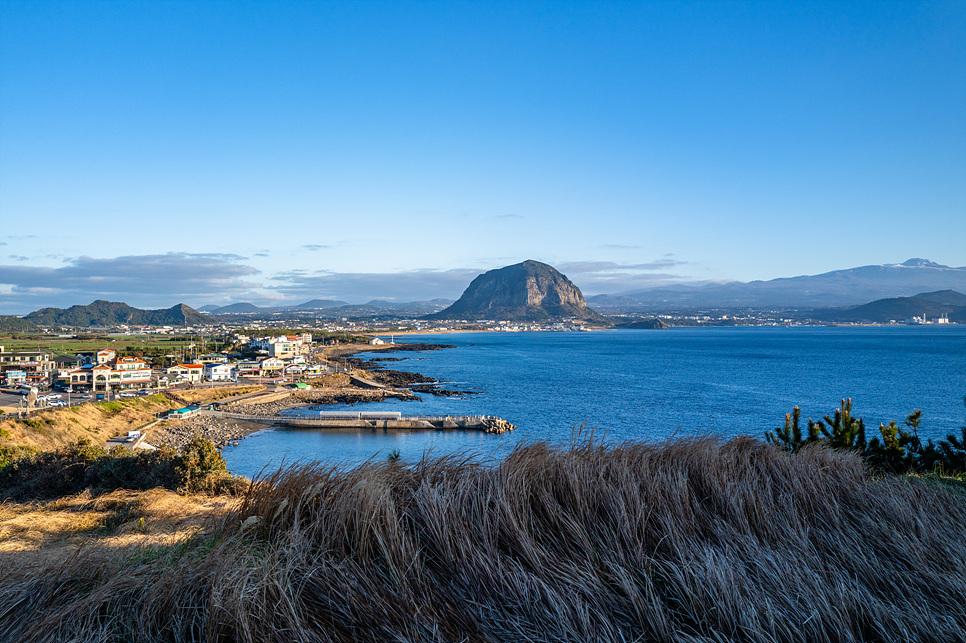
[204, 410, 516, 433]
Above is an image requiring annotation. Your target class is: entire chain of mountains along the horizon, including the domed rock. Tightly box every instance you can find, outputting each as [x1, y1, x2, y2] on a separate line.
[0, 259, 966, 332]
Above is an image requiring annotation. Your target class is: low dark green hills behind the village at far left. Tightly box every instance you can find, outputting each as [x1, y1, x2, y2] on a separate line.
[24, 299, 207, 327]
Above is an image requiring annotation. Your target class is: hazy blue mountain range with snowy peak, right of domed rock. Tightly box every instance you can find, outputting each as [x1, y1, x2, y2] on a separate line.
[587, 259, 966, 314]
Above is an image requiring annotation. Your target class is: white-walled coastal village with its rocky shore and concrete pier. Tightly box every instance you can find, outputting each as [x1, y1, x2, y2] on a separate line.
[0, 327, 514, 458]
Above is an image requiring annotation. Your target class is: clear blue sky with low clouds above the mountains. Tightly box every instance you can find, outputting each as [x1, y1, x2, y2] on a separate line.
[0, 0, 966, 314]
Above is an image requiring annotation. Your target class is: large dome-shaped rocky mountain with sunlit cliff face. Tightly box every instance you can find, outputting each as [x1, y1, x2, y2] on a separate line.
[431, 261, 605, 322]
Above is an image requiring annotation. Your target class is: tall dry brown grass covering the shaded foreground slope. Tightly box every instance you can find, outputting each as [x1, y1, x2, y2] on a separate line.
[0, 438, 966, 642]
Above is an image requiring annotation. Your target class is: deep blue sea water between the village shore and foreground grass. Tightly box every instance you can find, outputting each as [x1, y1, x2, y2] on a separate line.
[223, 326, 966, 476]
